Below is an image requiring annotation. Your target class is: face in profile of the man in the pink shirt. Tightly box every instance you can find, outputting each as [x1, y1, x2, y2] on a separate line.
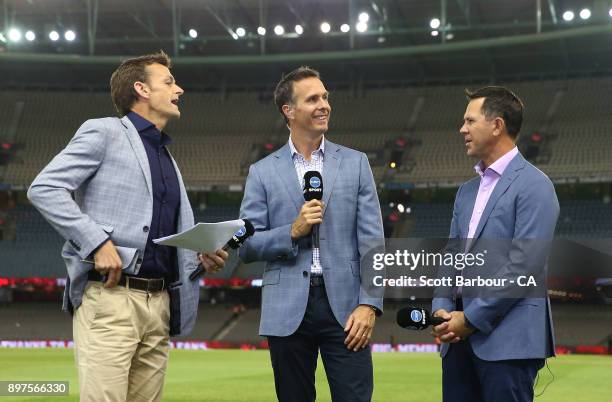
[459, 98, 499, 160]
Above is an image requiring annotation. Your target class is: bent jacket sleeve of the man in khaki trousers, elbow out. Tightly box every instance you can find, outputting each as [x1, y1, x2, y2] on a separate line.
[28, 120, 108, 258]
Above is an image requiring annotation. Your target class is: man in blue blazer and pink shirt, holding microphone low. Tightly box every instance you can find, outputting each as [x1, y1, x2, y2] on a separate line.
[432, 87, 559, 402]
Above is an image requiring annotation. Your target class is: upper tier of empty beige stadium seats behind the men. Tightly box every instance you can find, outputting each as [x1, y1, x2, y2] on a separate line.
[0, 78, 612, 189]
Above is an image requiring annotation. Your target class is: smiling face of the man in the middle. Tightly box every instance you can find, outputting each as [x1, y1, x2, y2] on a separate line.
[283, 77, 331, 136]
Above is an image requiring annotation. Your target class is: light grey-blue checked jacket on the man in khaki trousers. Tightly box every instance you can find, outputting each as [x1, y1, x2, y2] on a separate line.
[28, 117, 199, 335]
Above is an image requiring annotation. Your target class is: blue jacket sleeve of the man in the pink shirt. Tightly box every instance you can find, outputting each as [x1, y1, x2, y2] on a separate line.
[464, 177, 559, 333]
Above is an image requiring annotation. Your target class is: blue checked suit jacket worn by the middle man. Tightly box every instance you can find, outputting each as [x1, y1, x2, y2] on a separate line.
[240, 140, 384, 336]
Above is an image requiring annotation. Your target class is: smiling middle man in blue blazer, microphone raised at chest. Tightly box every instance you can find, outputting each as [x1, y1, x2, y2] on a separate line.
[240, 67, 384, 402]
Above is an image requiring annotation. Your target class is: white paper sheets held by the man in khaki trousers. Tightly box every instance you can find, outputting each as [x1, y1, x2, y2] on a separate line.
[153, 219, 244, 253]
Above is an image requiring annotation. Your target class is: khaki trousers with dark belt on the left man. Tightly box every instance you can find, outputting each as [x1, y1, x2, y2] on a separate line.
[73, 282, 170, 402]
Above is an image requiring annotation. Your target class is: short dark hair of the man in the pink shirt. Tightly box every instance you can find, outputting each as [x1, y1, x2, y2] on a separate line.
[465, 86, 524, 140]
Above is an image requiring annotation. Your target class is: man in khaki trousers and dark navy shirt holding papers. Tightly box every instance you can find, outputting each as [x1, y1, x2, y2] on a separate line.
[28, 52, 227, 401]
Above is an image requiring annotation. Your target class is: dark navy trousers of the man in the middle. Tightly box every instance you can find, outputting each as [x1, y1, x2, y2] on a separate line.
[268, 286, 374, 402]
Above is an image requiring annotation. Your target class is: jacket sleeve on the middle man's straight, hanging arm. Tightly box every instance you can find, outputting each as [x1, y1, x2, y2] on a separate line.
[357, 153, 385, 313]
